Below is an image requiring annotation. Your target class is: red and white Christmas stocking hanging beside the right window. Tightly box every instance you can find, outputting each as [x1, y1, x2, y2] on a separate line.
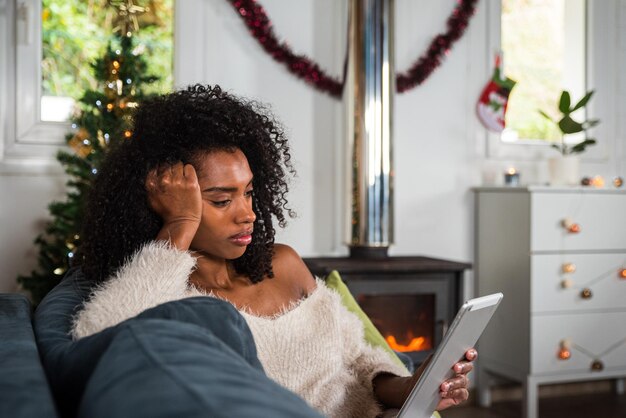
[476, 54, 516, 132]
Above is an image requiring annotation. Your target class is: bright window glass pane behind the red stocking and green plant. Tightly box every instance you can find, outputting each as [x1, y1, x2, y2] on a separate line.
[501, 0, 586, 142]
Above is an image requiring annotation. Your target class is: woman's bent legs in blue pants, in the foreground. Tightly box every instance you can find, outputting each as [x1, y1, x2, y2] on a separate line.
[78, 312, 321, 418]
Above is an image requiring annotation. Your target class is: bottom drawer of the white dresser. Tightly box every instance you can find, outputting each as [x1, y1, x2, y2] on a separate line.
[531, 312, 626, 375]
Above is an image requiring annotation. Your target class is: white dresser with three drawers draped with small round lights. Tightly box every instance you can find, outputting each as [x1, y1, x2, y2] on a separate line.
[475, 186, 626, 418]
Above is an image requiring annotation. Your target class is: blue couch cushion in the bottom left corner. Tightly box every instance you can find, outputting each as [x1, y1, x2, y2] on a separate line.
[0, 294, 57, 418]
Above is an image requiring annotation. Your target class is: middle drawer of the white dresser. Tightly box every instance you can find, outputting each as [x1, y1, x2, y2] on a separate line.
[530, 252, 626, 313]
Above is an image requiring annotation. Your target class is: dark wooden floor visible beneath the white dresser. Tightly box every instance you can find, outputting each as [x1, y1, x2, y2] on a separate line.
[441, 393, 626, 418]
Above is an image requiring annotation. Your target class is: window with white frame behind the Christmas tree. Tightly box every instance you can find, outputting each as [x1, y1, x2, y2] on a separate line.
[0, 0, 174, 164]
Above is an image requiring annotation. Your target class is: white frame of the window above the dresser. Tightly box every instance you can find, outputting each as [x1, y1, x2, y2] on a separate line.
[485, 0, 618, 162]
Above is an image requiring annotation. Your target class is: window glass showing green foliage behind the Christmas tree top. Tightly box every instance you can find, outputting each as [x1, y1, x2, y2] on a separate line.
[40, 0, 173, 122]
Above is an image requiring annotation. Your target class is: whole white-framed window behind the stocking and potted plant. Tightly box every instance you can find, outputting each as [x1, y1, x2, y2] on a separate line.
[477, 0, 619, 161]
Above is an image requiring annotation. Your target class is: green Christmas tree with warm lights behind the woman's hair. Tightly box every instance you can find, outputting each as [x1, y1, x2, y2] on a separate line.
[17, 0, 165, 304]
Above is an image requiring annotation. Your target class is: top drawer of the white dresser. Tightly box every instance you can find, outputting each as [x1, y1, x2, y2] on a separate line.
[530, 192, 626, 252]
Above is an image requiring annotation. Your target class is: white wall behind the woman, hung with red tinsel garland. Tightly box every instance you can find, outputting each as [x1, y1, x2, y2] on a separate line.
[0, 0, 626, 293]
